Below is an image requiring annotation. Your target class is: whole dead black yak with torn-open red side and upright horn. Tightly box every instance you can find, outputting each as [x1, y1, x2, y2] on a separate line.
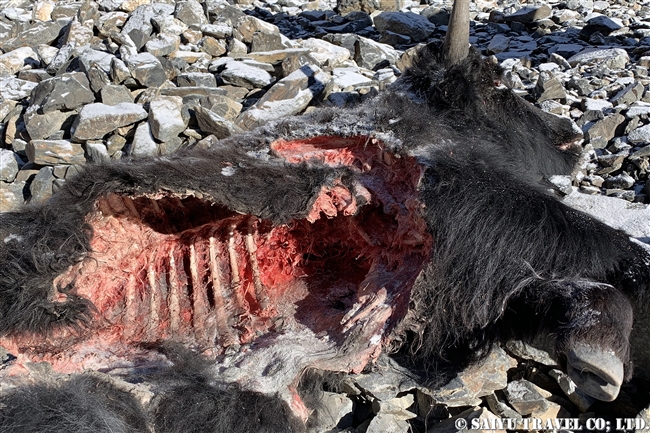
[0, 2, 650, 431]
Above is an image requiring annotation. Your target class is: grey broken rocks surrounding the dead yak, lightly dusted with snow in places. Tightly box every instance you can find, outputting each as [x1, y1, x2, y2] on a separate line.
[0, 0, 650, 433]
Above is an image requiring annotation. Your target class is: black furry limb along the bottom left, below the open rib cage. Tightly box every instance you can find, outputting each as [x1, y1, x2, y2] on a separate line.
[0, 345, 302, 433]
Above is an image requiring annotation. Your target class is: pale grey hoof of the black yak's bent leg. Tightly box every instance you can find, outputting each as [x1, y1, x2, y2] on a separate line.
[567, 344, 624, 401]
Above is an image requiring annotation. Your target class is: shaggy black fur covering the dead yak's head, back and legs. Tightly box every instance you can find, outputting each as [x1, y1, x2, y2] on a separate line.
[0, 45, 650, 432]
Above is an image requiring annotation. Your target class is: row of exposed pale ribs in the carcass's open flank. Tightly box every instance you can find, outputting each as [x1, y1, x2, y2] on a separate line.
[76, 194, 274, 347]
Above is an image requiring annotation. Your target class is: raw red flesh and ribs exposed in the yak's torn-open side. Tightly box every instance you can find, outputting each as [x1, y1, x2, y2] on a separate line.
[0, 137, 431, 378]
